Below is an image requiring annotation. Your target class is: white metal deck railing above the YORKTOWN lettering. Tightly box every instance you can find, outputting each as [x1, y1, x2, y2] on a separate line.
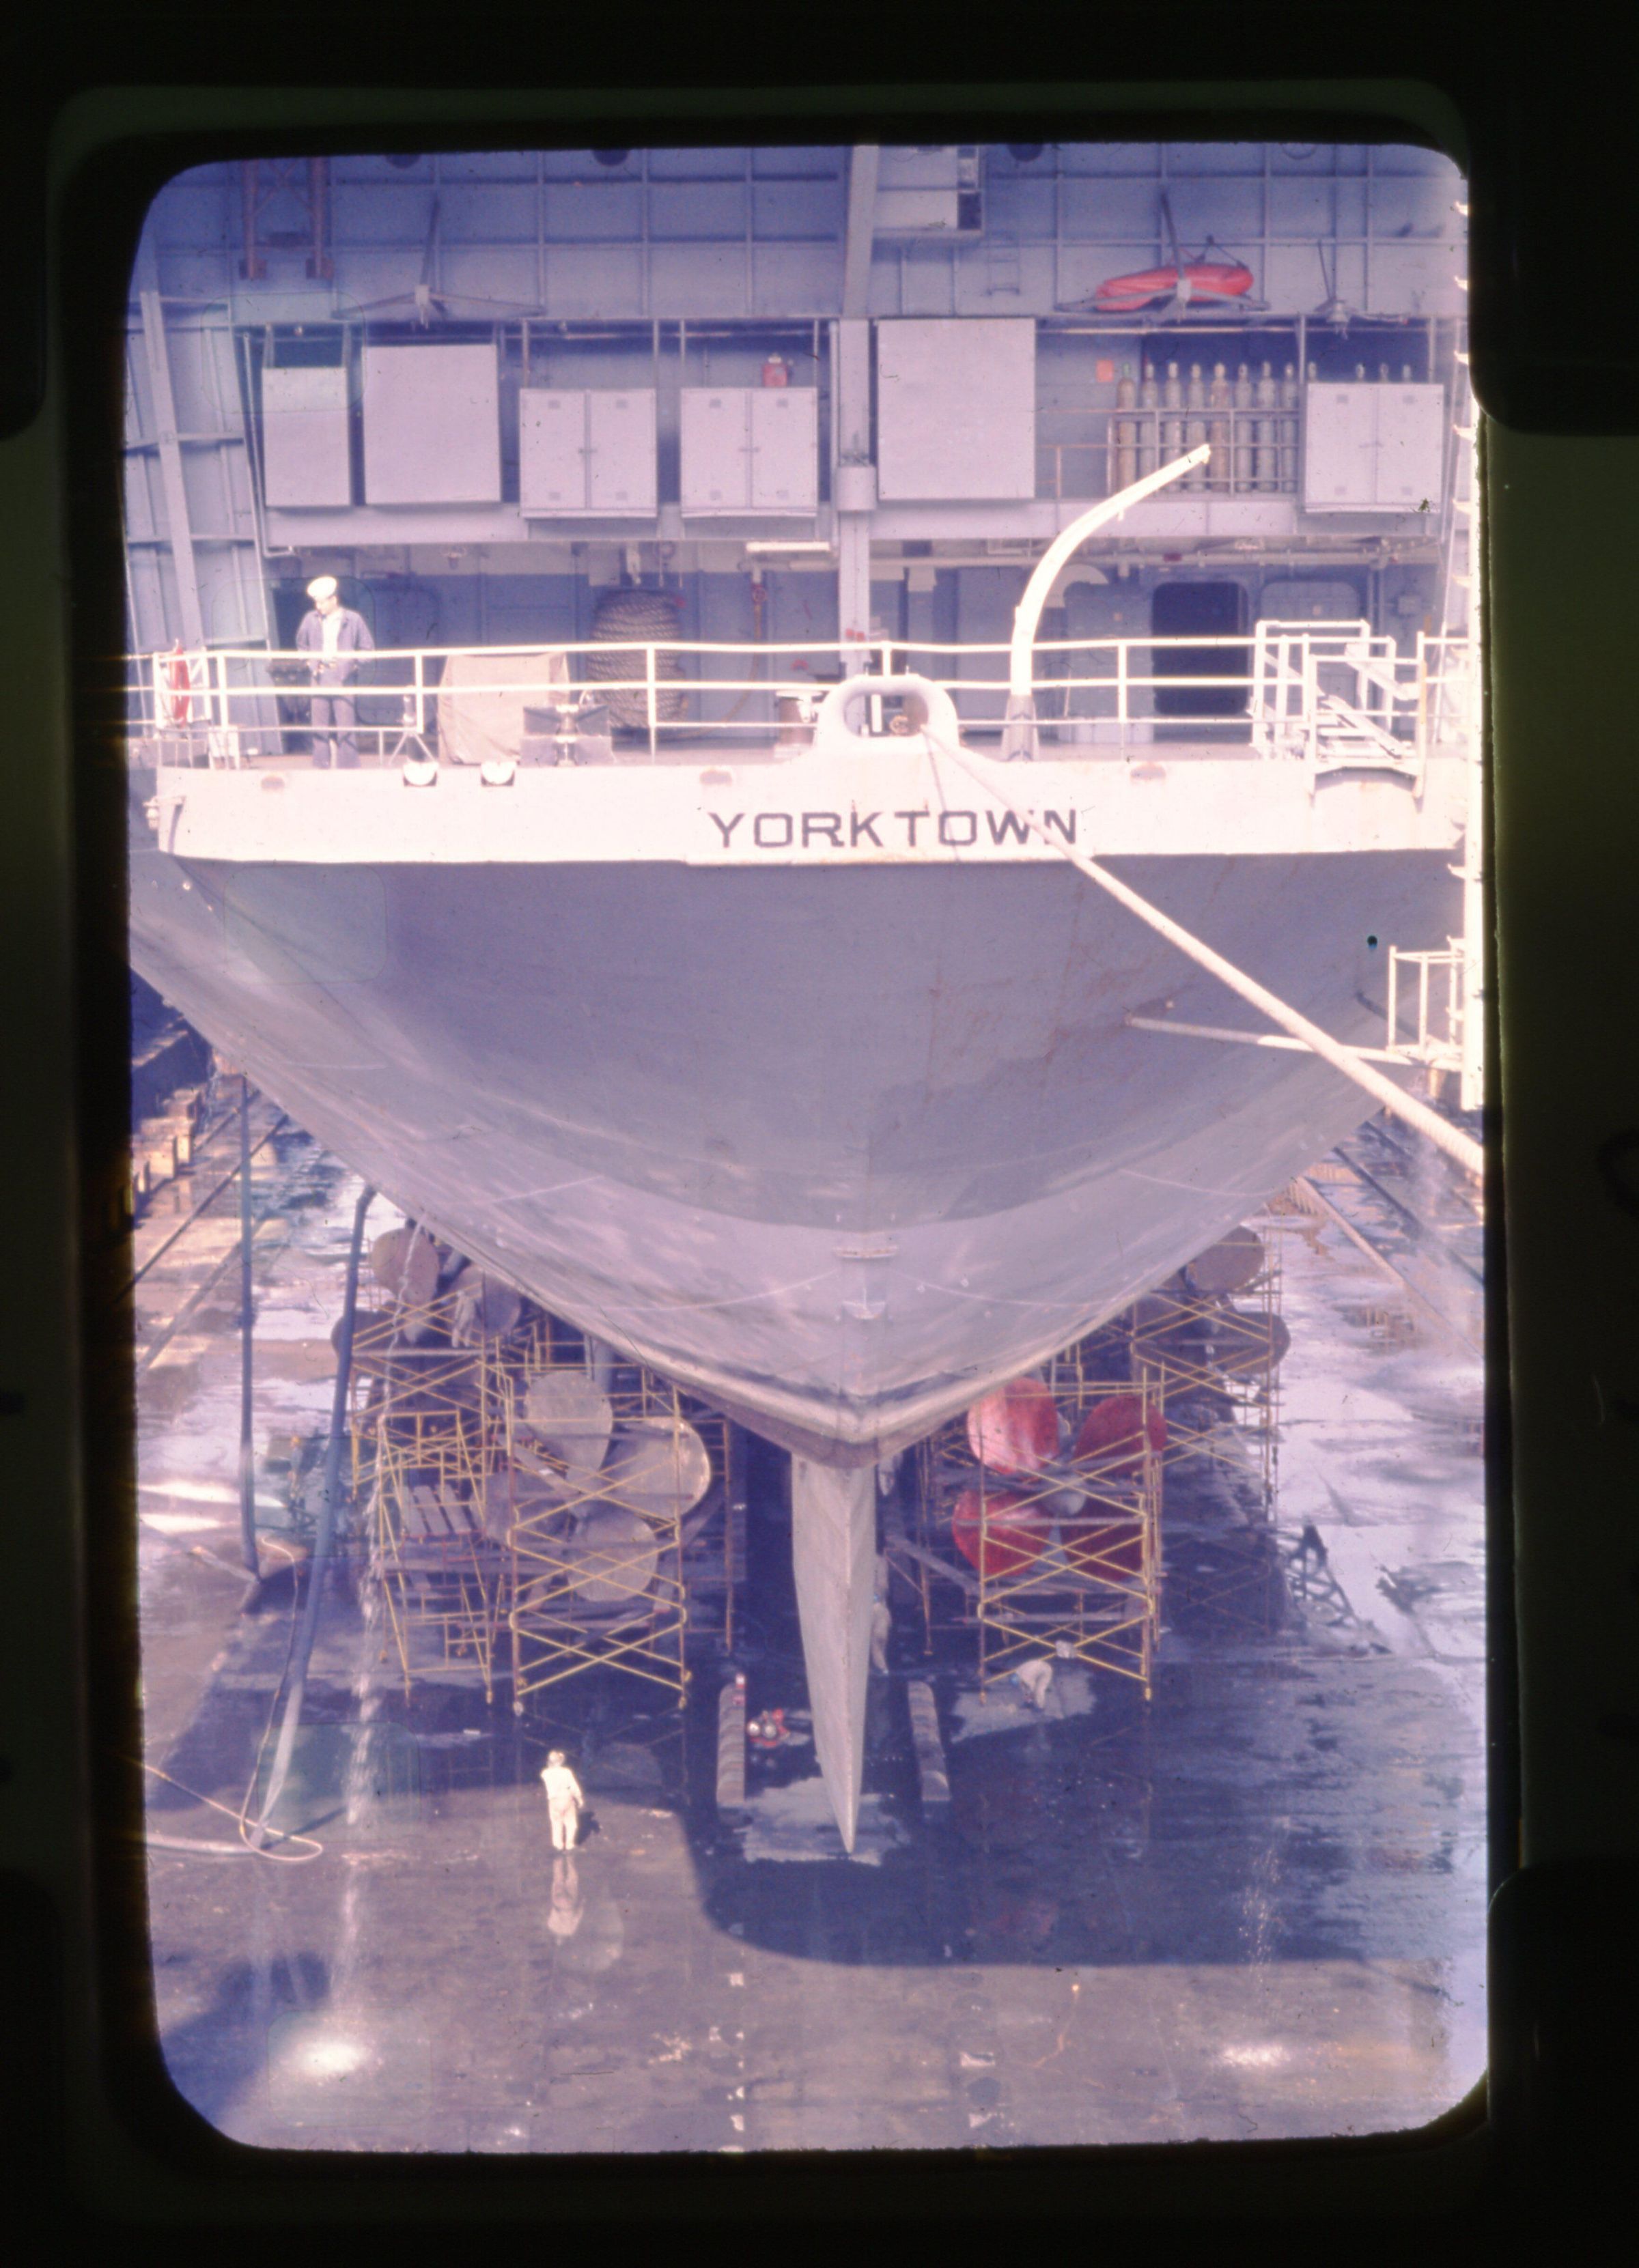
[127, 621, 1473, 778]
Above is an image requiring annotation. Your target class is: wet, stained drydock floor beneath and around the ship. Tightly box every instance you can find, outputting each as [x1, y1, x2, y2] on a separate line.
[139, 1107, 1485, 2153]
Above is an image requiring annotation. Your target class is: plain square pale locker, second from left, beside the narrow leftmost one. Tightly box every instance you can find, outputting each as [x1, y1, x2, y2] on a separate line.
[363, 343, 502, 503]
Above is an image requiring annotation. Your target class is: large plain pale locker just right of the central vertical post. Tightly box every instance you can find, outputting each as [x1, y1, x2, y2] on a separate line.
[876, 315, 1035, 503]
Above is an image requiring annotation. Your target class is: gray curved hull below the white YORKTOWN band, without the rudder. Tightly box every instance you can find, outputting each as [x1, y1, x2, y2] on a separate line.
[132, 816, 1455, 1465]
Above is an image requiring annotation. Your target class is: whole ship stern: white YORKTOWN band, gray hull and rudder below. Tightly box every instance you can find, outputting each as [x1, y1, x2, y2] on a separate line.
[132, 741, 1462, 1851]
